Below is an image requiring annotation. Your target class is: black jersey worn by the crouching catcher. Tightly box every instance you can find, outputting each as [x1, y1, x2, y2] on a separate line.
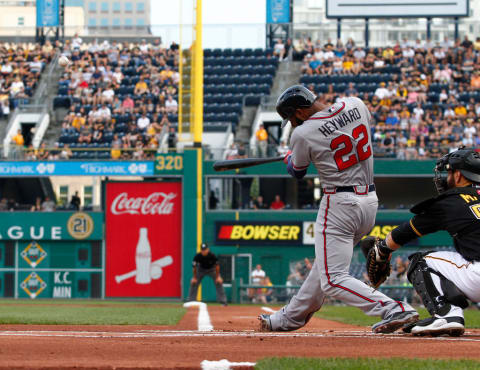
[406, 186, 480, 261]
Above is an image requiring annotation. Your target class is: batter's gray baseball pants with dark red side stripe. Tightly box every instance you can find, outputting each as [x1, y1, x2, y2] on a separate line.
[270, 192, 413, 331]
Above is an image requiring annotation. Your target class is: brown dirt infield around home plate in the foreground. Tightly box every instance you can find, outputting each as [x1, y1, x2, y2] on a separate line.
[0, 306, 480, 369]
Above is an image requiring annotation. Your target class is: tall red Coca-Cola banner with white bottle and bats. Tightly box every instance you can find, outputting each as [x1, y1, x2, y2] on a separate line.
[105, 182, 182, 297]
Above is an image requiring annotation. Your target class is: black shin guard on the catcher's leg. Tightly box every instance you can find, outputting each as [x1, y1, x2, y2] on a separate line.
[407, 252, 468, 316]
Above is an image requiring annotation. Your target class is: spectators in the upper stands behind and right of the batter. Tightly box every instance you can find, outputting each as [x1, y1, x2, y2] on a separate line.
[286, 36, 480, 159]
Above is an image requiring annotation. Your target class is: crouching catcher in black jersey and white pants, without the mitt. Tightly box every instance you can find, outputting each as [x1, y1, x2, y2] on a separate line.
[375, 147, 480, 336]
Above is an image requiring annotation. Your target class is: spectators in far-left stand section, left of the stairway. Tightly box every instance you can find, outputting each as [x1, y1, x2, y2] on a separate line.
[0, 41, 56, 118]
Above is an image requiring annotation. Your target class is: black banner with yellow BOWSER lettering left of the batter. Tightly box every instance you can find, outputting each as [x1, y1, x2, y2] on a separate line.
[215, 221, 303, 246]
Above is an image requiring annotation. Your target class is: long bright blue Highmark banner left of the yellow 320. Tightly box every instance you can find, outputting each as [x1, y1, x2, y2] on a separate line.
[0, 161, 154, 177]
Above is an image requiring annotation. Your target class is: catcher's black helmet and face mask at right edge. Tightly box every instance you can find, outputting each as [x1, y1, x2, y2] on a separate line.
[433, 146, 480, 194]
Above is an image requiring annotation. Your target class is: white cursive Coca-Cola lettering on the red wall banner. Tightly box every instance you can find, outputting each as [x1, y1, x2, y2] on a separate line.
[110, 192, 177, 215]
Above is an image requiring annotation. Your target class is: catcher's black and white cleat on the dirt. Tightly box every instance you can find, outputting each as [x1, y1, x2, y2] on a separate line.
[403, 316, 465, 337]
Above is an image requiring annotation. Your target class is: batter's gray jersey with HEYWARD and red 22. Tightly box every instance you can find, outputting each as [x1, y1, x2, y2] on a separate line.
[290, 97, 373, 187]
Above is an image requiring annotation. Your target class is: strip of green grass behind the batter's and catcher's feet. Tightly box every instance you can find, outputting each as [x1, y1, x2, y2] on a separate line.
[315, 306, 480, 328]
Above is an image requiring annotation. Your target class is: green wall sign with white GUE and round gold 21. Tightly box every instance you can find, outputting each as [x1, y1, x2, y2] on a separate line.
[0, 212, 103, 240]
